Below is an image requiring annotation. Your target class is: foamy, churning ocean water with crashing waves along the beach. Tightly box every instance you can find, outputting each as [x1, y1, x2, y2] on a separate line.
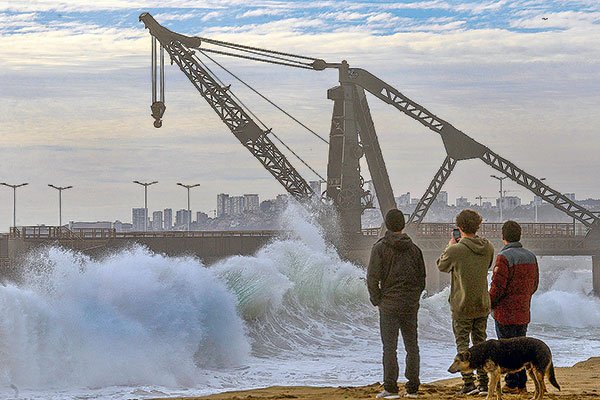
[0, 209, 600, 399]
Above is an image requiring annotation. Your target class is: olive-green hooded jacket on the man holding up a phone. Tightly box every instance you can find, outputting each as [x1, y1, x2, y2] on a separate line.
[437, 236, 494, 319]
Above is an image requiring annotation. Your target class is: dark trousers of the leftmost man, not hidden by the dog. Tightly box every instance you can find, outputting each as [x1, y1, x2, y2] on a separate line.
[379, 307, 420, 393]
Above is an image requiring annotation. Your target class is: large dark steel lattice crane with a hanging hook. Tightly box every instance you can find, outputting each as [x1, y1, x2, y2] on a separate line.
[140, 13, 600, 242]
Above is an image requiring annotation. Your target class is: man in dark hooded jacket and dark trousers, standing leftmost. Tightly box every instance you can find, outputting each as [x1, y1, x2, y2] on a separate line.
[367, 209, 425, 399]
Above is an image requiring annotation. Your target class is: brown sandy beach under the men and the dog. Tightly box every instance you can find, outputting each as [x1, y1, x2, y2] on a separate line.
[156, 357, 600, 400]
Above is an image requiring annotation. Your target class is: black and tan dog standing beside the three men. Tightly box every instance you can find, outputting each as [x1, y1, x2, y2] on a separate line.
[448, 337, 560, 400]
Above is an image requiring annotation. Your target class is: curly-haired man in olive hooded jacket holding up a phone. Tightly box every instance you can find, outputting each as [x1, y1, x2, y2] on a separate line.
[437, 210, 494, 394]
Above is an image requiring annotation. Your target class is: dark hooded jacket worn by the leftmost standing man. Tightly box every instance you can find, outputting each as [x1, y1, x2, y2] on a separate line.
[367, 231, 425, 313]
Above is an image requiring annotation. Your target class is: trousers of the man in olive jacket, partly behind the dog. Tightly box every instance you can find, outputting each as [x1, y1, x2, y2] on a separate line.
[452, 316, 488, 387]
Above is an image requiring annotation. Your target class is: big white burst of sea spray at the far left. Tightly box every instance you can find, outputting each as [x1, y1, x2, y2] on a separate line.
[0, 246, 250, 388]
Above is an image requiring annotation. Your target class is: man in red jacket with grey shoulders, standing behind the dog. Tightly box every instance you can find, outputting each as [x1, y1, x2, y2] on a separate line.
[490, 221, 539, 394]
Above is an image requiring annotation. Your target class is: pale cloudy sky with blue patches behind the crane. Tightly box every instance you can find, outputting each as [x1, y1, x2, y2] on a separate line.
[0, 0, 600, 227]
